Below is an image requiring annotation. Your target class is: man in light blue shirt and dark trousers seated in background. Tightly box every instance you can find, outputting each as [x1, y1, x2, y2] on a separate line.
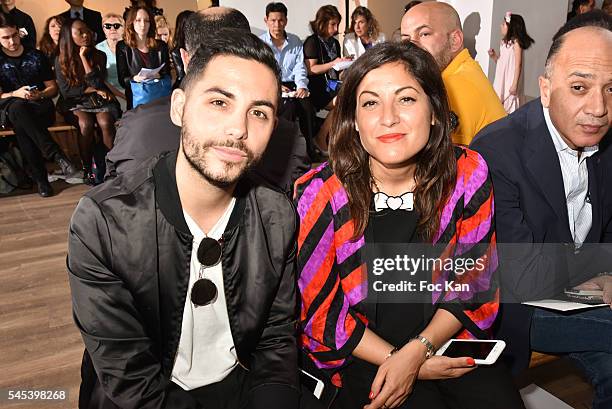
[259, 2, 317, 160]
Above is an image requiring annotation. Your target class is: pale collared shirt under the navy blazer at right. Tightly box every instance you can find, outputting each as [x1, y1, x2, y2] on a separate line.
[543, 108, 599, 247]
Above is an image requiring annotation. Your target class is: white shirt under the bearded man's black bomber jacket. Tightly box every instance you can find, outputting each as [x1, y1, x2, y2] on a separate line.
[172, 199, 238, 390]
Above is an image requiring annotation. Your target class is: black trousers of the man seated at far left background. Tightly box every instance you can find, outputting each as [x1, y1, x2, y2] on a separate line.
[8, 98, 61, 182]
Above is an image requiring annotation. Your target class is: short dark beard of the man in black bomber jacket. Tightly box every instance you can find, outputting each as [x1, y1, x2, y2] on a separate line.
[181, 124, 260, 189]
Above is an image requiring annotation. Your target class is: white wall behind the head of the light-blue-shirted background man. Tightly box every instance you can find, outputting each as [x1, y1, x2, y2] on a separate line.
[219, 0, 344, 40]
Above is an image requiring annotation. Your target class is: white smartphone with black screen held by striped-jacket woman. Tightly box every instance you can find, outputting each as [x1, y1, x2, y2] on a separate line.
[436, 339, 506, 365]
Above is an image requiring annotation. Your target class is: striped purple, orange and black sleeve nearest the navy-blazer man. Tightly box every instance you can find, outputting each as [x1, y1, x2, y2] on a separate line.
[433, 149, 499, 338]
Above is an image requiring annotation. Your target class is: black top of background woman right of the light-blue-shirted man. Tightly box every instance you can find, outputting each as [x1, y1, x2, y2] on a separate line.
[304, 34, 340, 109]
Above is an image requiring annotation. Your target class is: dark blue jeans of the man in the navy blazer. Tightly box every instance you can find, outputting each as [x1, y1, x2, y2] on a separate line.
[531, 307, 612, 409]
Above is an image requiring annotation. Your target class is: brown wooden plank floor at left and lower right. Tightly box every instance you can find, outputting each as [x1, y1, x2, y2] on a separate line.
[0, 182, 592, 409]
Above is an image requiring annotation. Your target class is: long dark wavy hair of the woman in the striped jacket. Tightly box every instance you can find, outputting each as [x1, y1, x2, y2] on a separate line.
[329, 42, 457, 240]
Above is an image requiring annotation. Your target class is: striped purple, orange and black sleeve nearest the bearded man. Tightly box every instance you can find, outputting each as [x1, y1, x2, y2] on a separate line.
[295, 165, 367, 370]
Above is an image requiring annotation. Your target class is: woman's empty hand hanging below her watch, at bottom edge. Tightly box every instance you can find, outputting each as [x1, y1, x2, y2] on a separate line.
[364, 341, 426, 409]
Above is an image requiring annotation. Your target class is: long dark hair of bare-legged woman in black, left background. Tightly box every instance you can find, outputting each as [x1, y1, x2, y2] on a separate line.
[58, 19, 106, 87]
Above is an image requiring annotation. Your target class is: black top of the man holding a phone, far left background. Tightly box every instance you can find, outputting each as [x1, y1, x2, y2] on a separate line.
[0, 48, 54, 92]
